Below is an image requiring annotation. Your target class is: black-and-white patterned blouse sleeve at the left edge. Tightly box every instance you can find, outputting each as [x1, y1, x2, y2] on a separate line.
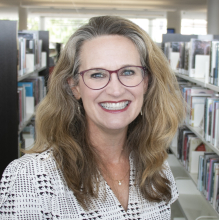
[0, 160, 44, 220]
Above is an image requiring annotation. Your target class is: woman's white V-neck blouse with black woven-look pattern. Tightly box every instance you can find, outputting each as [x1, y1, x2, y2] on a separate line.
[0, 151, 178, 220]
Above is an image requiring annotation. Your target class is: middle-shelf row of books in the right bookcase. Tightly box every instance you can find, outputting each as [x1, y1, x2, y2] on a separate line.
[179, 80, 219, 148]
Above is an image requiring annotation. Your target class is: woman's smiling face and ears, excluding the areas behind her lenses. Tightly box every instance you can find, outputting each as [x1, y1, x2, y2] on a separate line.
[73, 35, 148, 131]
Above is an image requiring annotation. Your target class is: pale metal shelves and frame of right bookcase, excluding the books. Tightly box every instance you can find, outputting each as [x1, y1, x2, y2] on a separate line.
[162, 34, 219, 220]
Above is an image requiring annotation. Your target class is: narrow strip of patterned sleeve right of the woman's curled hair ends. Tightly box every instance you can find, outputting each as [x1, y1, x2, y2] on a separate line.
[164, 160, 179, 204]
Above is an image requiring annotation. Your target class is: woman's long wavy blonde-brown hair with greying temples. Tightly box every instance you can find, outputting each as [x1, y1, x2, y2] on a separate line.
[29, 16, 184, 207]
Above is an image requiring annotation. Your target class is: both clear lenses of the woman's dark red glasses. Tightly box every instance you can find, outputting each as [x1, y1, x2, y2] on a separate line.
[83, 66, 143, 89]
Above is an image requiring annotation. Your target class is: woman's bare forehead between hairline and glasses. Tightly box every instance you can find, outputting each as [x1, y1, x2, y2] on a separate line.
[80, 35, 140, 68]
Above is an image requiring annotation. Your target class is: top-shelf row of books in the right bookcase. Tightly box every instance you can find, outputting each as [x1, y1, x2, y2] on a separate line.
[164, 38, 219, 86]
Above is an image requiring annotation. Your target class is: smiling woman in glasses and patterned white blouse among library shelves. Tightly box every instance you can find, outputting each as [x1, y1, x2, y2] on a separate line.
[0, 16, 184, 220]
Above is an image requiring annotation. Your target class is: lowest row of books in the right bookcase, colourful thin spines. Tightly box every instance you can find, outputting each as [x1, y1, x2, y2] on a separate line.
[173, 126, 219, 212]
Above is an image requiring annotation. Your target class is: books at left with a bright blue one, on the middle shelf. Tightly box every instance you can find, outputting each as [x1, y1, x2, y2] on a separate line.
[18, 76, 46, 128]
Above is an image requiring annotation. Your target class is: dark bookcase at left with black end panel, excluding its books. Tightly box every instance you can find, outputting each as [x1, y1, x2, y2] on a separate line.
[0, 20, 49, 175]
